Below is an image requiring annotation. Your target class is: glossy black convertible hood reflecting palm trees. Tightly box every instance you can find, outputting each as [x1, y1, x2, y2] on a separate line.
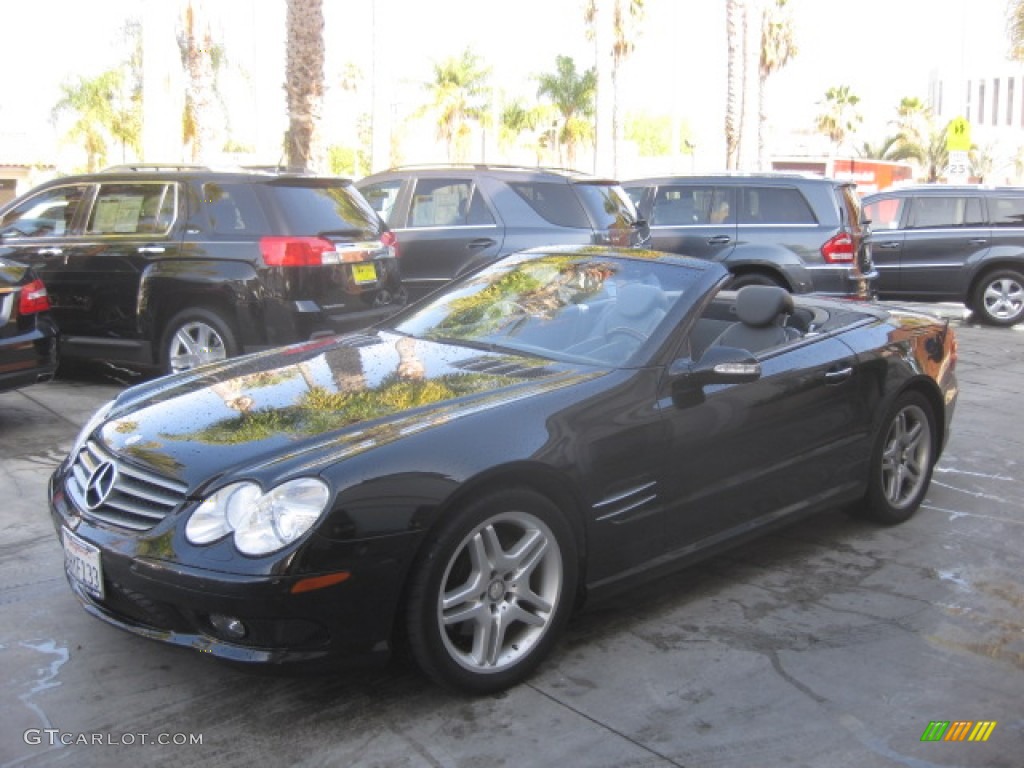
[100, 332, 606, 488]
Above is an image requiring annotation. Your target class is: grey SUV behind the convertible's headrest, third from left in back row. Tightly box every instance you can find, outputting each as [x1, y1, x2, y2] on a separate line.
[623, 174, 876, 298]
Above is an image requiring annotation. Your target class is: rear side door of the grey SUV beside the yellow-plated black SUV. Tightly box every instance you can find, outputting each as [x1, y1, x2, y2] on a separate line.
[389, 177, 503, 300]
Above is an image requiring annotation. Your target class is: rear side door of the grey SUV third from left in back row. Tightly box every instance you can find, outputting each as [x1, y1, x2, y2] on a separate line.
[649, 184, 736, 260]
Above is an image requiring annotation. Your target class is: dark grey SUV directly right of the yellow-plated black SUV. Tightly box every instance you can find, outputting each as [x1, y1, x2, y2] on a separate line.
[355, 165, 646, 298]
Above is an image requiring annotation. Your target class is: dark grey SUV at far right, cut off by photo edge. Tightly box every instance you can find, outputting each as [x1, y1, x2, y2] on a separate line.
[864, 184, 1024, 326]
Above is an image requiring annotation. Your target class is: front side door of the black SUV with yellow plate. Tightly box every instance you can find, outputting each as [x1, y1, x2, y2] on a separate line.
[0, 182, 95, 333]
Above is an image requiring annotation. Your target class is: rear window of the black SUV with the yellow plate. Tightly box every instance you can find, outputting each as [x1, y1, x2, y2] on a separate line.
[263, 179, 381, 237]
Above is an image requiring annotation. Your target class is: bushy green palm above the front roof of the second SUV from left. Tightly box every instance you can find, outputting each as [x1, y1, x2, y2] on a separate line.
[419, 48, 490, 161]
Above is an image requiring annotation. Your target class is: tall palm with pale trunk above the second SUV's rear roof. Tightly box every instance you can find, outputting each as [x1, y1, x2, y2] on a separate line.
[584, 0, 644, 176]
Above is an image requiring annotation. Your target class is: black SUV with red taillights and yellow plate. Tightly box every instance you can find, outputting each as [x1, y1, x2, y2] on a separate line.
[0, 166, 404, 372]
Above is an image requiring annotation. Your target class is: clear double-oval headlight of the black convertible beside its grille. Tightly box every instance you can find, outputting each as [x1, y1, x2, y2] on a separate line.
[185, 477, 330, 555]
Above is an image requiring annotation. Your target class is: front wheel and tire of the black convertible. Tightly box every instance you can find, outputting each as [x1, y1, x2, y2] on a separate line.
[406, 488, 578, 694]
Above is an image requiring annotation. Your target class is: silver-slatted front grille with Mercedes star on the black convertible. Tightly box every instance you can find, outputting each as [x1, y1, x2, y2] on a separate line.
[68, 440, 188, 530]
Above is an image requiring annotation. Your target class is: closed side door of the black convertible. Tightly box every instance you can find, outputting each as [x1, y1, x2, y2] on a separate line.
[659, 325, 867, 555]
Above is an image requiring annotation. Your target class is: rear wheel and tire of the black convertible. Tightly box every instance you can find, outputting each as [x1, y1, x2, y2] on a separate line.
[857, 392, 937, 525]
